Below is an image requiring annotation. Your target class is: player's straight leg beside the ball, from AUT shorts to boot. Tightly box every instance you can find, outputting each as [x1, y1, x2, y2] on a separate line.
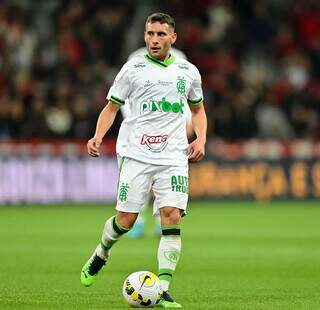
[153, 167, 188, 308]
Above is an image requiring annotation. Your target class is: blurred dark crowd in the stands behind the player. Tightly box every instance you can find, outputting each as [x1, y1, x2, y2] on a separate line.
[0, 0, 320, 141]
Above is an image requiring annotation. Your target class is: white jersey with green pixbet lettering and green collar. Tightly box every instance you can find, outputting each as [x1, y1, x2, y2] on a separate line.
[107, 55, 203, 166]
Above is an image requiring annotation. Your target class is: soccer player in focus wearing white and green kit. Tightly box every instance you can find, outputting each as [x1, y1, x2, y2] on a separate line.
[81, 13, 207, 308]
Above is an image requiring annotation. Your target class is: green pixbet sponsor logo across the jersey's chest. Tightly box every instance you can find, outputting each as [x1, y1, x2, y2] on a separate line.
[140, 98, 184, 114]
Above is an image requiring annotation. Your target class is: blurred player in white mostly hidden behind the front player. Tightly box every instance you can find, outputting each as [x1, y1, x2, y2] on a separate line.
[122, 47, 193, 239]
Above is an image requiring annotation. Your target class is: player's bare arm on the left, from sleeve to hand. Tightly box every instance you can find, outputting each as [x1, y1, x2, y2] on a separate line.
[87, 100, 120, 157]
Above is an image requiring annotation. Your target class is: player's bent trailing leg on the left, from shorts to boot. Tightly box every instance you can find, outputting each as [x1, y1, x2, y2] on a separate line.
[81, 158, 151, 286]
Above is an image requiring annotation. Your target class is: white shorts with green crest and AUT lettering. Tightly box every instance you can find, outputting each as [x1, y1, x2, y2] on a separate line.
[116, 157, 189, 214]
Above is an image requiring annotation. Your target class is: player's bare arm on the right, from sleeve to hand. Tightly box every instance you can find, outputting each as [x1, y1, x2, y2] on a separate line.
[188, 103, 207, 161]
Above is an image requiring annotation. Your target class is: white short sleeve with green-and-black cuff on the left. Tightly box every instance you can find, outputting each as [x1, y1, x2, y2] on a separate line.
[107, 63, 130, 106]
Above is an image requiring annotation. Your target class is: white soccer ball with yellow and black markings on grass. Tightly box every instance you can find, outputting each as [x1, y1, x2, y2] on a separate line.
[122, 271, 162, 308]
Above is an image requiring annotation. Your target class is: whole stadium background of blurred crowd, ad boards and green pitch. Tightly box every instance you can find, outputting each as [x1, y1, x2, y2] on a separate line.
[0, 0, 320, 309]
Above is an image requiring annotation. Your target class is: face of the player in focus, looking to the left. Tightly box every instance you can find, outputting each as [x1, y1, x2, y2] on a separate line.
[144, 22, 177, 61]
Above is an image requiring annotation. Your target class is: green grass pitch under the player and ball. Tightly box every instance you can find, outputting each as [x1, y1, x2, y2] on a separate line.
[0, 202, 320, 310]
